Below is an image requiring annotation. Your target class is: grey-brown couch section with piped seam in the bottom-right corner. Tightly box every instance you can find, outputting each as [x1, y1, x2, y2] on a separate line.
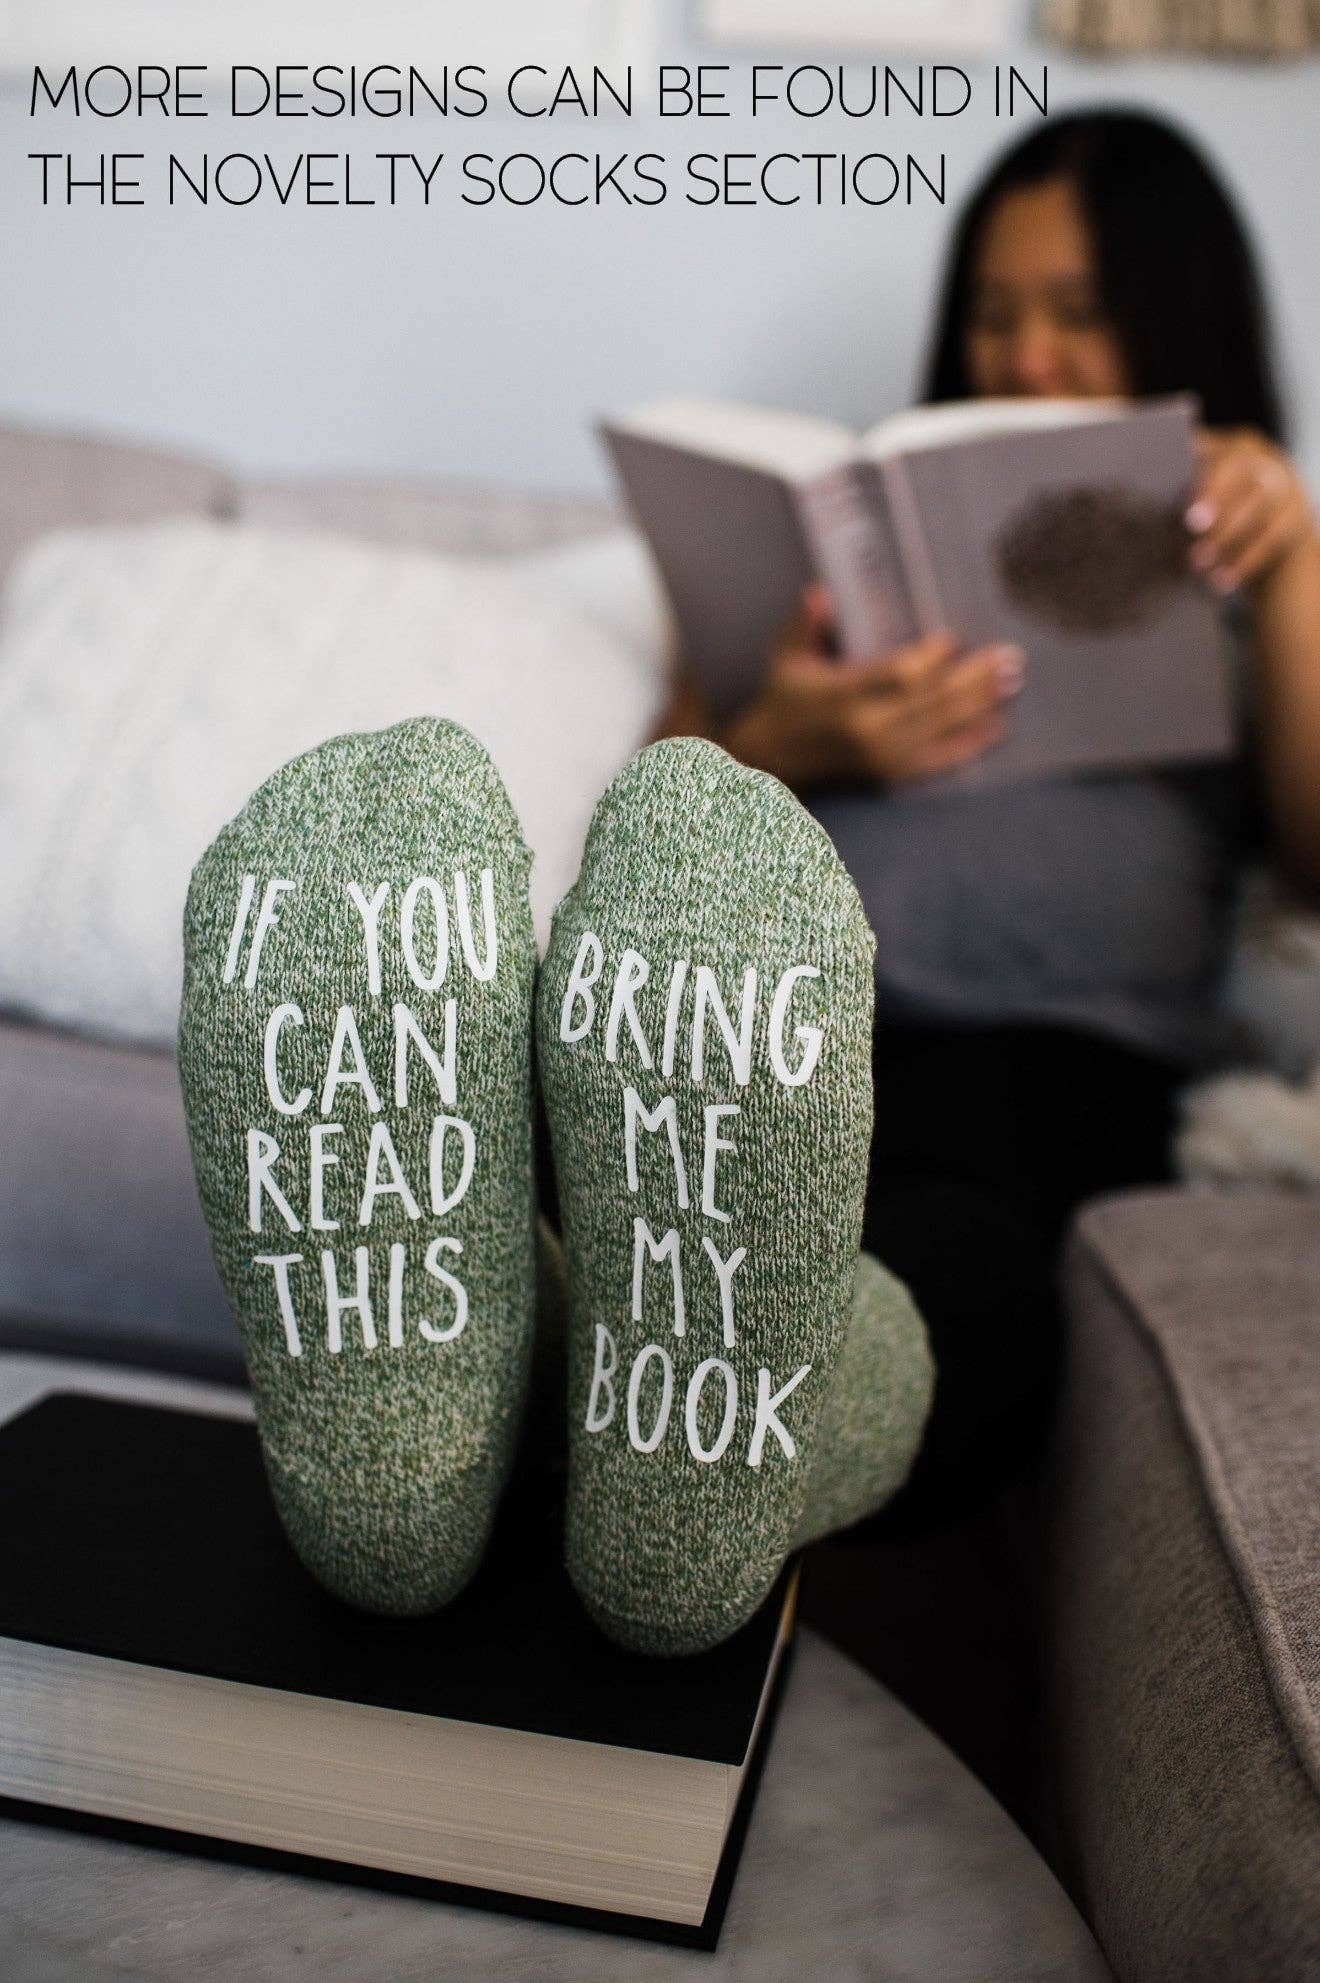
[1054, 1192, 1320, 1979]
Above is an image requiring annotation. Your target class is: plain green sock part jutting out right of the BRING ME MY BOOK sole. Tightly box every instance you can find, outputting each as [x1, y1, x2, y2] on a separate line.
[793, 1253, 935, 1549]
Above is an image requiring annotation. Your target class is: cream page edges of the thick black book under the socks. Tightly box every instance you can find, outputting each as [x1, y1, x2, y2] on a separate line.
[0, 1638, 729, 1925]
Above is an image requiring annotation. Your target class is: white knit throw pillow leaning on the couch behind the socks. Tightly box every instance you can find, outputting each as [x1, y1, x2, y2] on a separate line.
[0, 522, 668, 1041]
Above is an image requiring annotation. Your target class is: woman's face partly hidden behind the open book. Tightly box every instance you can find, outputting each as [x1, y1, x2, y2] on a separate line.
[963, 178, 1132, 399]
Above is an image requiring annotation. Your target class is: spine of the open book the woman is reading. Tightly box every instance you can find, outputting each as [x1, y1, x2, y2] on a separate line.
[797, 462, 918, 656]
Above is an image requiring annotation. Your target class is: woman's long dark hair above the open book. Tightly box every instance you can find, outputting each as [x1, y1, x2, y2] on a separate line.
[924, 111, 1284, 440]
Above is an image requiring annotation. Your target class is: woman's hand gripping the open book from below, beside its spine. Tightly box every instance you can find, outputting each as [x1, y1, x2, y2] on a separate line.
[719, 585, 1023, 789]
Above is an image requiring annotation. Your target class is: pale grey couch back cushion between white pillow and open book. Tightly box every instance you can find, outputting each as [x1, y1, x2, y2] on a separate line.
[238, 476, 618, 557]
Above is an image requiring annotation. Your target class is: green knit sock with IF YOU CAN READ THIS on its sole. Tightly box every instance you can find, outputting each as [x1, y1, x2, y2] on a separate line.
[178, 720, 535, 1616]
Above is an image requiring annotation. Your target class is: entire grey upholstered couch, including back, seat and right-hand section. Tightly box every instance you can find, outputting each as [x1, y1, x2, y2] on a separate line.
[0, 414, 1320, 1983]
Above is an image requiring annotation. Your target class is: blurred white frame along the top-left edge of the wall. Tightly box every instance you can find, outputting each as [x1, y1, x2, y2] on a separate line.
[0, 0, 658, 75]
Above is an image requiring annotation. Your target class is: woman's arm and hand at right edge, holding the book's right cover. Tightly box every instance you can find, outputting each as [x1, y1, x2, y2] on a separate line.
[1187, 432, 1320, 888]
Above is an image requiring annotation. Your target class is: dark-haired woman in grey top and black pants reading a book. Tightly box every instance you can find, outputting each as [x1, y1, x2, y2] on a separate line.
[666, 113, 1320, 1519]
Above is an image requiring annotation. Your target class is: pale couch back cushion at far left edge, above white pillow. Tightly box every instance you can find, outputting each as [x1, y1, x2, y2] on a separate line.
[0, 426, 234, 579]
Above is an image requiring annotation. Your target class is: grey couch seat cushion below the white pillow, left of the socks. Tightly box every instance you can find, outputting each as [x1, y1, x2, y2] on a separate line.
[0, 1021, 242, 1374]
